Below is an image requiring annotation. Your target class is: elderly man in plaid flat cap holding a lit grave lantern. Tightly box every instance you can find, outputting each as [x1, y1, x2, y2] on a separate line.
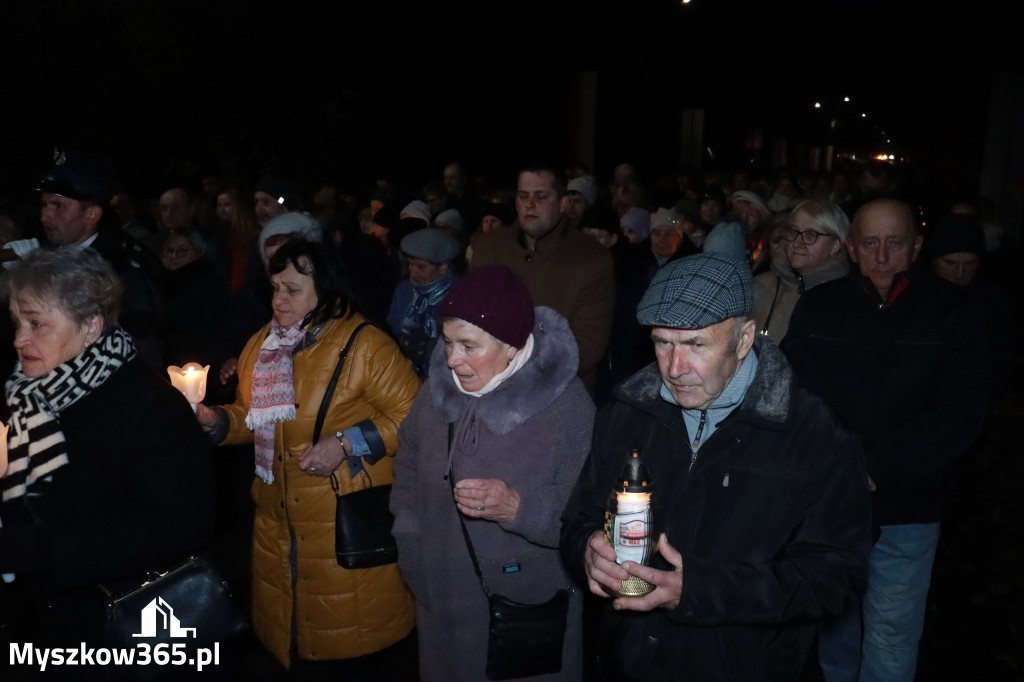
[561, 254, 871, 682]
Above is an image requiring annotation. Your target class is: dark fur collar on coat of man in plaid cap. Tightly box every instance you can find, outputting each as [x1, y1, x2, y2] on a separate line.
[615, 334, 794, 428]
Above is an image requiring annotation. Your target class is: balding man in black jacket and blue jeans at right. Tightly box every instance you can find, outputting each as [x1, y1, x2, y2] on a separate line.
[782, 199, 990, 682]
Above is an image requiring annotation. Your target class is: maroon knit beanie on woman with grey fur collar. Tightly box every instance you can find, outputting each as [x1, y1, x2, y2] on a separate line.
[437, 260, 534, 348]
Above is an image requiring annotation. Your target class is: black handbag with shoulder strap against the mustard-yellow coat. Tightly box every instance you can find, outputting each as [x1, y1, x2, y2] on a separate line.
[312, 323, 398, 568]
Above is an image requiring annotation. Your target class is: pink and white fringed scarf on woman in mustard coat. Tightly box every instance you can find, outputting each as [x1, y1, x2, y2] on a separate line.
[246, 321, 306, 484]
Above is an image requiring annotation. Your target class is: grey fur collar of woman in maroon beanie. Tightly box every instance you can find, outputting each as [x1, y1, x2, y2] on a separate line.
[425, 306, 580, 433]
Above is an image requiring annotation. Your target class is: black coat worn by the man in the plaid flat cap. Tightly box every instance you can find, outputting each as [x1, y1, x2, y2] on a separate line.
[562, 338, 870, 682]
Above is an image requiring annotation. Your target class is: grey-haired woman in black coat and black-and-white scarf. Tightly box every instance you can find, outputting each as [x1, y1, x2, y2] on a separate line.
[0, 248, 213, 647]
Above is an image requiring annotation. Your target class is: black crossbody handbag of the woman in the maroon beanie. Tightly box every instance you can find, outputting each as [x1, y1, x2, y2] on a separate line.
[446, 423, 569, 680]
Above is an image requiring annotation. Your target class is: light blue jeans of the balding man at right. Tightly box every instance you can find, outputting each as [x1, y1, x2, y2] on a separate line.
[818, 523, 939, 682]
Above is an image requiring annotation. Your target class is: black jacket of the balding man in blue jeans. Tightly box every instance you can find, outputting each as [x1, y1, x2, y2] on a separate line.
[782, 271, 991, 525]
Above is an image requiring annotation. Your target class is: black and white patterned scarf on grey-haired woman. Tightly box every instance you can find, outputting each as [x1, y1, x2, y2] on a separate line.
[0, 330, 135, 502]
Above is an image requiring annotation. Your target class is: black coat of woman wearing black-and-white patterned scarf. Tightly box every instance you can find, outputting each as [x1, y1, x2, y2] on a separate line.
[0, 359, 214, 641]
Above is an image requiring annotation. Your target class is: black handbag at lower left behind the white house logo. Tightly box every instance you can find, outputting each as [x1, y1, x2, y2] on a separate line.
[99, 557, 248, 647]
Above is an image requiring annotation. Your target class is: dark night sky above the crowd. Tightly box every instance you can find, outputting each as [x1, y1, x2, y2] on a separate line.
[0, 0, 1021, 200]
